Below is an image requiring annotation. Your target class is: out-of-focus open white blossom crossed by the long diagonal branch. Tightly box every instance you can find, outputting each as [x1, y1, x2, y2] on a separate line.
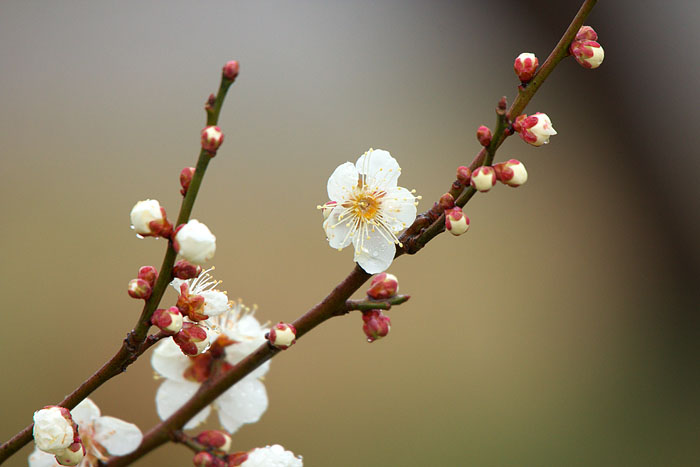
[151, 301, 270, 433]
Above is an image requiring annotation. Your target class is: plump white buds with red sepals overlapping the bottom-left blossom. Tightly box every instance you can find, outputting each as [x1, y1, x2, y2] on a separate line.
[33, 405, 85, 465]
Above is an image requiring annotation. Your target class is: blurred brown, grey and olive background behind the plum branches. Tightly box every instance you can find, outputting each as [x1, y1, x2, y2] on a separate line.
[0, 0, 700, 467]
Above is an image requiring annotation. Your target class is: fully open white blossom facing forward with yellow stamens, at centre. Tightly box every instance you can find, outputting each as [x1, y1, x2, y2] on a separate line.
[320, 149, 417, 274]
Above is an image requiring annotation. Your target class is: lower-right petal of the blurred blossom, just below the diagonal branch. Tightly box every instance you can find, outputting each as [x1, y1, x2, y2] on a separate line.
[214, 376, 267, 433]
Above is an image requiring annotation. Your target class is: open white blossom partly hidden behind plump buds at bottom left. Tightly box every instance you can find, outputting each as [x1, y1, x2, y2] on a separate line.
[29, 399, 143, 467]
